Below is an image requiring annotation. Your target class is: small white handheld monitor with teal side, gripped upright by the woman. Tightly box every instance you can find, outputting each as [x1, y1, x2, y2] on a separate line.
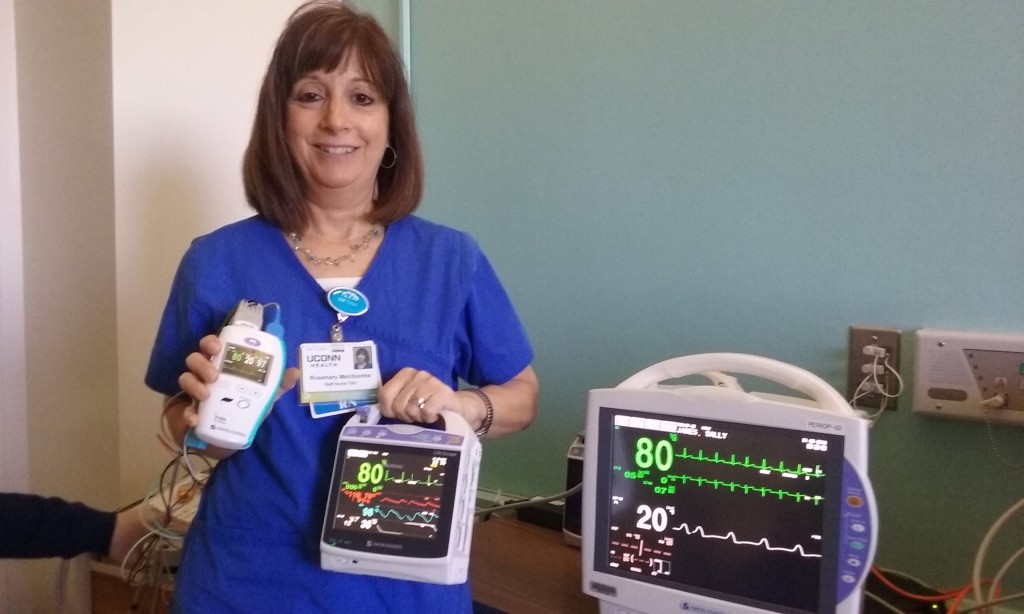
[195, 301, 285, 450]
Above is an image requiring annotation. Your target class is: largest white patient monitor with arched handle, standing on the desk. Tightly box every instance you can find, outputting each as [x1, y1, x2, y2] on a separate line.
[582, 354, 878, 614]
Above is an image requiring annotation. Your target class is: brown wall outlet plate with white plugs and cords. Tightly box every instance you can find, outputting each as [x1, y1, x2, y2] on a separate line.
[846, 326, 900, 409]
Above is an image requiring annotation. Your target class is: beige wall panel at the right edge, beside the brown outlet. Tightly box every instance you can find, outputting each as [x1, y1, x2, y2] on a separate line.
[913, 328, 1024, 426]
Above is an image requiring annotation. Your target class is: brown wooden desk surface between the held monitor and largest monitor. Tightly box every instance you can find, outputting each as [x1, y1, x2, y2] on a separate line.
[469, 518, 598, 614]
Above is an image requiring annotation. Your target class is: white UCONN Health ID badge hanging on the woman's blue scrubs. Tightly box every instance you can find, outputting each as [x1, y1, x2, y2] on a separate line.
[299, 341, 381, 418]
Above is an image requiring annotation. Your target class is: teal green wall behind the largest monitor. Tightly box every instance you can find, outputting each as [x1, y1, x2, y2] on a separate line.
[412, 0, 1024, 589]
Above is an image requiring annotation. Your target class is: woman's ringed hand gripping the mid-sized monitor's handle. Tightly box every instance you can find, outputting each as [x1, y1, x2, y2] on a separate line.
[378, 366, 459, 425]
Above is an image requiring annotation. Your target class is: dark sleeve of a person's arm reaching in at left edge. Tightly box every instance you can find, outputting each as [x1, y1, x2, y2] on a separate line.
[0, 492, 117, 559]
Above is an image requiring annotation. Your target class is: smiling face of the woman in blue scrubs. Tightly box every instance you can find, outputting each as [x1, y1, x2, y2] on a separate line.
[287, 57, 388, 205]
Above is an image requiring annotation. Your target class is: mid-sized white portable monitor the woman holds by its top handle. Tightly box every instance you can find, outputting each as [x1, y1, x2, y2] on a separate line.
[321, 406, 480, 584]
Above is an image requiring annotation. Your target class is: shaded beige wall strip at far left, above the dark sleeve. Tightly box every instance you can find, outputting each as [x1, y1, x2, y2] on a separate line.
[15, 0, 117, 505]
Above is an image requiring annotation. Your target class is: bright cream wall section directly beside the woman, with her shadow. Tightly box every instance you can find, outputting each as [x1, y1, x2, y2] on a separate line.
[112, 0, 298, 500]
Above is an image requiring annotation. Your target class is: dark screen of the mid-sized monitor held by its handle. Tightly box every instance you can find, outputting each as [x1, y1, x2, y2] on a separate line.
[324, 441, 461, 558]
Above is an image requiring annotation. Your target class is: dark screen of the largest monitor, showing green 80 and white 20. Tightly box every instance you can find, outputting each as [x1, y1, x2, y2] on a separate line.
[587, 407, 844, 612]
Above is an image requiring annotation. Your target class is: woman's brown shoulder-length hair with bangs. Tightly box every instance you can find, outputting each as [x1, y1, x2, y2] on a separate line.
[242, 0, 423, 231]
